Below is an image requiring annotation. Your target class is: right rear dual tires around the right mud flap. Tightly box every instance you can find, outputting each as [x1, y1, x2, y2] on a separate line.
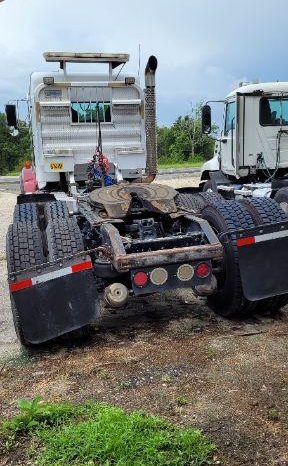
[202, 198, 288, 317]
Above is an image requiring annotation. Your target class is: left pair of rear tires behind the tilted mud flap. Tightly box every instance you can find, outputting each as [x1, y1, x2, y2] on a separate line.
[6, 201, 91, 347]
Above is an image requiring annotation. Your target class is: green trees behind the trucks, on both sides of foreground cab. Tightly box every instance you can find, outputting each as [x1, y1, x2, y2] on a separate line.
[0, 105, 217, 175]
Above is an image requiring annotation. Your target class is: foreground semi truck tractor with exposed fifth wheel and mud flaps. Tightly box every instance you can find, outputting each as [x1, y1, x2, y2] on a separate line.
[6, 52, 288, 346]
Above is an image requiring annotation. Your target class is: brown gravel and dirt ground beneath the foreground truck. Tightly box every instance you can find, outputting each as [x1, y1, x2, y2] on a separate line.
[0, 175, 288, 466]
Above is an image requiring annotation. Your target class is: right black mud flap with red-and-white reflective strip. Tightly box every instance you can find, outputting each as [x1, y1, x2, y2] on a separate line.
[236, 222, 288, 301]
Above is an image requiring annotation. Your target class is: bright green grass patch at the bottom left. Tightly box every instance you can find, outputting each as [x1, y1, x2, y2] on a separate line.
[0, 399, 215, 466]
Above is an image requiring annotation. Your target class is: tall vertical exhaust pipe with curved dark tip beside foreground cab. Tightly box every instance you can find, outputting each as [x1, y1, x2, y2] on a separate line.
[141, 55, 158, 183]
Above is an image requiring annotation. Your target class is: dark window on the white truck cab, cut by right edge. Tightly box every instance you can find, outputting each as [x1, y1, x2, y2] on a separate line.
[259, 97, 288, 126]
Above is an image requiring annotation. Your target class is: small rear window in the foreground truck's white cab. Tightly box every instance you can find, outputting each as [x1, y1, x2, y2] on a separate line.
[71, 102, 111, 123]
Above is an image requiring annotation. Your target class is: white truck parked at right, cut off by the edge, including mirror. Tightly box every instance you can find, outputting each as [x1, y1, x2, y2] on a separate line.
[201, 82, 288, 212]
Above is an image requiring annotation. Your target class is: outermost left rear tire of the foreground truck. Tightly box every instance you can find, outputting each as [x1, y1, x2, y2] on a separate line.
[6, 222, 46, 347]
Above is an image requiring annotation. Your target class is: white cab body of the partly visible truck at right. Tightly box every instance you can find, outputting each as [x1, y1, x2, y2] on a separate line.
[201, 82, 288, 182]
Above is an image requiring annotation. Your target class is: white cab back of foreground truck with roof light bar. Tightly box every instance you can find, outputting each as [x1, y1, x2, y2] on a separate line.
[22, 52, 150, 190]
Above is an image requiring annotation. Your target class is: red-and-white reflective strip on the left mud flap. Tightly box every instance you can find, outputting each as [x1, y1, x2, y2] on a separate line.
[9, 261, 93, 293]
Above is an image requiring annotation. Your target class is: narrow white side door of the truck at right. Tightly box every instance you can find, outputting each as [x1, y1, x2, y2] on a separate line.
[221, 100, 237, 176]
